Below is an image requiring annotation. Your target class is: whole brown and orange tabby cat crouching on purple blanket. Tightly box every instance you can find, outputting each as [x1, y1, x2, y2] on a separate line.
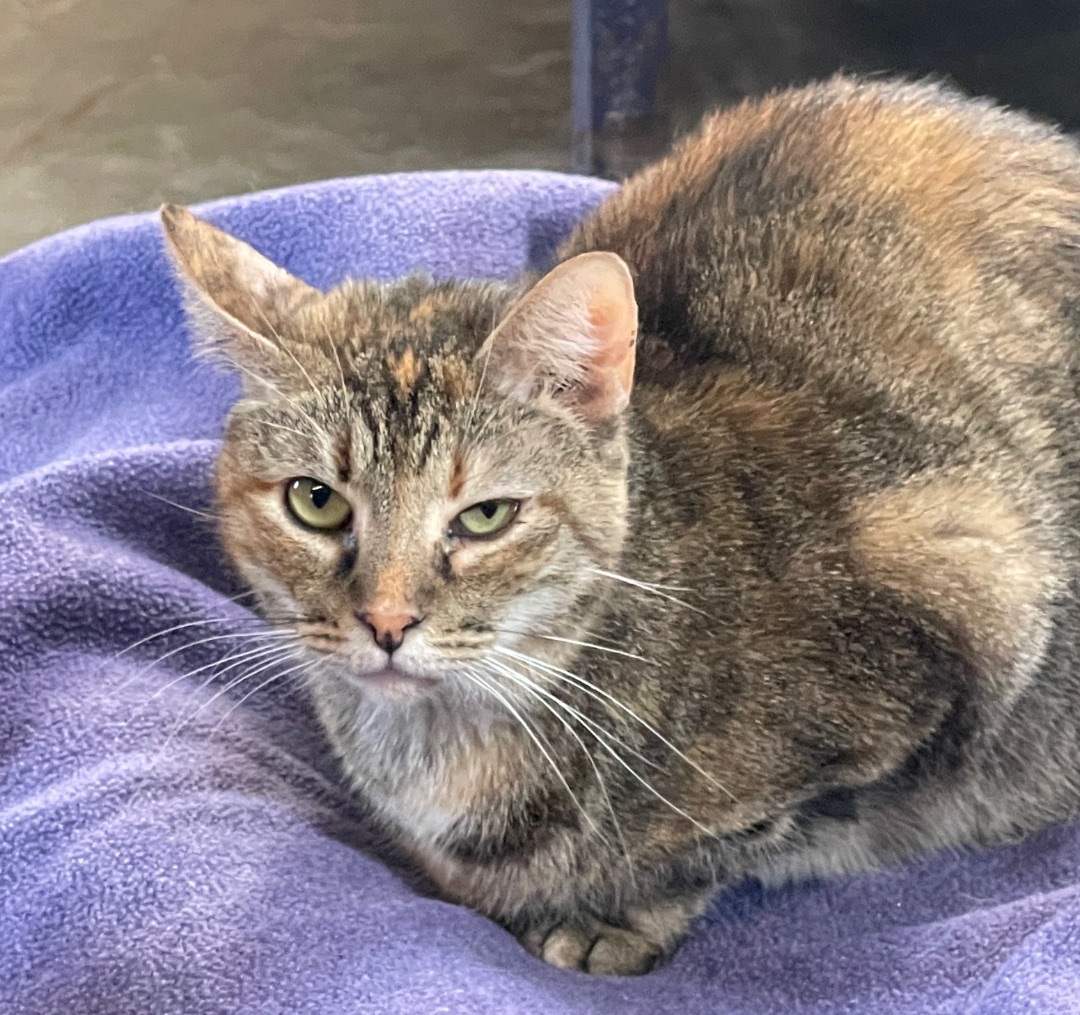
[162, 77, 1080, 974]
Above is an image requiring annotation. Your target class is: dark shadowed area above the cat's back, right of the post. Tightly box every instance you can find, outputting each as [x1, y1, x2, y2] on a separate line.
[664, 0, 1080, 131]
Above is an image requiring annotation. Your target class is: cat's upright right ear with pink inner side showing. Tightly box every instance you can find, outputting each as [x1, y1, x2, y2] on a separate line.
[477, 252, 637, 422]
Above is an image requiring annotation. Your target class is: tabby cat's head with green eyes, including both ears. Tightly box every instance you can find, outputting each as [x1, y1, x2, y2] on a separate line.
[162, 207, 637, 699]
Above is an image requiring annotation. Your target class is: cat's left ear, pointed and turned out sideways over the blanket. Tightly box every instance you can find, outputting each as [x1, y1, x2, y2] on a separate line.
[161, 204, 322, 394]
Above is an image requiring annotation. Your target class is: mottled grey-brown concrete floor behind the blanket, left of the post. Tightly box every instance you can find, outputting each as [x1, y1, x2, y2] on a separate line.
[0, 0, 569, 253]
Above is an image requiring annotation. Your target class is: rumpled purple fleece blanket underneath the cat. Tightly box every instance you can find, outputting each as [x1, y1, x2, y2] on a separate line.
[0, 173, 1080, 1015]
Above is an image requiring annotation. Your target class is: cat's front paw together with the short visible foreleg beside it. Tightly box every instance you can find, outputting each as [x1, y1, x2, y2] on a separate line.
[518, 893, 712, 976]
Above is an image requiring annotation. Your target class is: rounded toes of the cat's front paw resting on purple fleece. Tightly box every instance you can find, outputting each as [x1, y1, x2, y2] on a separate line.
[522, 919, 663, 976]
